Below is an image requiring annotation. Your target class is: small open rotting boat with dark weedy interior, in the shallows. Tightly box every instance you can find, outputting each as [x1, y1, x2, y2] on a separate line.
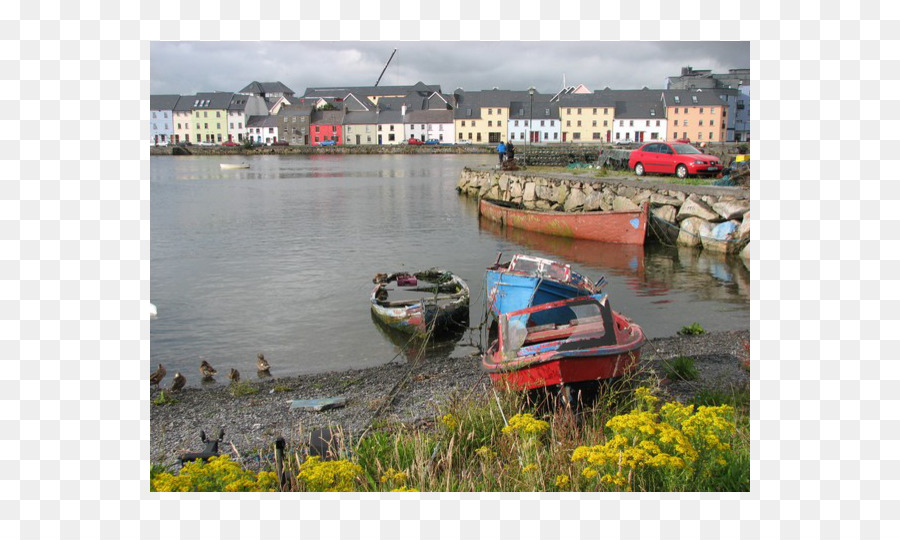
[372, 268, 469, 336]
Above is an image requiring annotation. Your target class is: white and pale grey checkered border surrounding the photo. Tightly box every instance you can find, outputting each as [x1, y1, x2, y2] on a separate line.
[0, 0, 888, 539]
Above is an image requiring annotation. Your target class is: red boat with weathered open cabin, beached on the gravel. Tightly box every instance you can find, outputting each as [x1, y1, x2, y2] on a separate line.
[482, 293, 645, 392]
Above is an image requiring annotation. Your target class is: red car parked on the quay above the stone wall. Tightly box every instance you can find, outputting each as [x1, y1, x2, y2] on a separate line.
[628, 142, 722, 178]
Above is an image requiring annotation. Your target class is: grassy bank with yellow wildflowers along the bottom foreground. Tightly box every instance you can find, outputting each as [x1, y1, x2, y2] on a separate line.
[151, 378, 750, 491]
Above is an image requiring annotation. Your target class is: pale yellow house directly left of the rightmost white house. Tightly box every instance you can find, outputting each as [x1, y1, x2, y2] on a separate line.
[558, 92, 616, 144]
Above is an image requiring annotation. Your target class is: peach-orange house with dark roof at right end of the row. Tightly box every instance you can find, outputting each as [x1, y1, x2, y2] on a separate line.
[662, 90, 728, 143]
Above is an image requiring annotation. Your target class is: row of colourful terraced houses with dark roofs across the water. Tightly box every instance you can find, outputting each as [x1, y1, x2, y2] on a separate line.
[150, 68, 749, 146]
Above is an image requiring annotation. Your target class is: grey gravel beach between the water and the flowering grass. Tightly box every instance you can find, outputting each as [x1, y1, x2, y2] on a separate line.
[150, 330, 750, 465]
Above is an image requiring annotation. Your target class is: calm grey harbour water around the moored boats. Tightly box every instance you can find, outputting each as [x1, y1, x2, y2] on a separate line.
[150, 155, 750, 384]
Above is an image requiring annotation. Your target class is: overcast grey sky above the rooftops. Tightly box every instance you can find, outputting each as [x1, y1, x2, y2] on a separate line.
[150, 41, 750, 96]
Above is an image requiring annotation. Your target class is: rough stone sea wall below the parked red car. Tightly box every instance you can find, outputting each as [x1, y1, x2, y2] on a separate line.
[456, 168, 752, 261]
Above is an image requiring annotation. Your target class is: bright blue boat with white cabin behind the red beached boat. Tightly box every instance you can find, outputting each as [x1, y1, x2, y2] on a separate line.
[485, 253, 605, 315]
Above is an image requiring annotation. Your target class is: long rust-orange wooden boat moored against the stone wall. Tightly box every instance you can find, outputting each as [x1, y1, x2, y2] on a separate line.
[478, 199, 650, 245]
